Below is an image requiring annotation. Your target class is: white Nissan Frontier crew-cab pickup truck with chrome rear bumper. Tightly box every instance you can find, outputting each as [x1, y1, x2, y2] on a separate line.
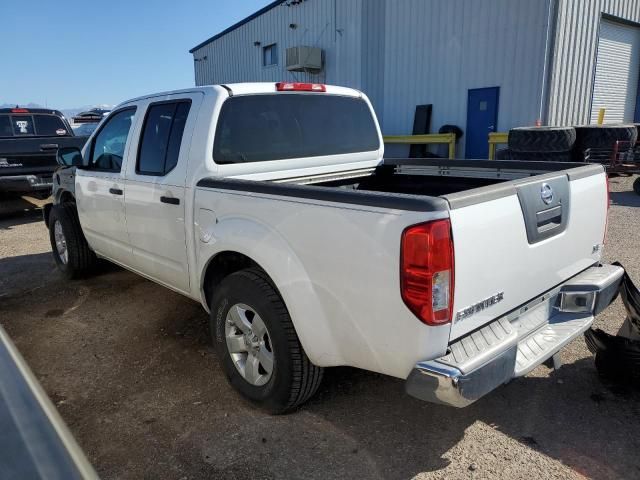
[45, 83, 623, 413]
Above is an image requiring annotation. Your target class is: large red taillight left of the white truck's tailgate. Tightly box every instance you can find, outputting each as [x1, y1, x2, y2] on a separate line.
[400, 219, 454, 325]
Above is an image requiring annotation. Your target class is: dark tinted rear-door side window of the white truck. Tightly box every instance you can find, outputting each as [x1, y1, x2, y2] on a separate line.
[136, 101, 191, 176]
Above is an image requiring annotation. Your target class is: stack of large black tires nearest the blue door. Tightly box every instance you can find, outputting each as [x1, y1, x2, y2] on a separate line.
[508, 127, 576, 162]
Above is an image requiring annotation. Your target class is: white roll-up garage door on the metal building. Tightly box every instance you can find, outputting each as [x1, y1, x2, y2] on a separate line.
[591, 20, 640, 123]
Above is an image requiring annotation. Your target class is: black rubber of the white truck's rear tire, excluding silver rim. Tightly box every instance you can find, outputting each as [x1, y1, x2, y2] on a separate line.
[210, 268, 323, 414]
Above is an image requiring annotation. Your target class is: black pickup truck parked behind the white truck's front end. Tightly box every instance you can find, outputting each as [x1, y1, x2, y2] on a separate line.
[0, 107, 87, 198]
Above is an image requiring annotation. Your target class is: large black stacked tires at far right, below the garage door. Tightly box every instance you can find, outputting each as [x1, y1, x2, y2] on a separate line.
[574, 124, 638, 163]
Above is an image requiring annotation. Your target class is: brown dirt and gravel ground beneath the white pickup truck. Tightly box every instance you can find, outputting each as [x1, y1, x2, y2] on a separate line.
[0, 178, 640, 480]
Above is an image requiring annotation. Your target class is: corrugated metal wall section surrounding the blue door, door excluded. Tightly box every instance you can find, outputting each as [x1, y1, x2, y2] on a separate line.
[383, 0, 551, 155]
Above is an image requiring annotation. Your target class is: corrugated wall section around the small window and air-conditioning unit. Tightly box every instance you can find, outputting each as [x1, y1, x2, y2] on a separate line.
[193, 0, 363, 88]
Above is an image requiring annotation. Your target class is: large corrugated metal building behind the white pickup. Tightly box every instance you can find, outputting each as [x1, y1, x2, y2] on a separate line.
[191, 0, 640, 157]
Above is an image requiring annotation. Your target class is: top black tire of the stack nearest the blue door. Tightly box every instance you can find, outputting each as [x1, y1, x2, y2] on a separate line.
[509, 127, 576, 153]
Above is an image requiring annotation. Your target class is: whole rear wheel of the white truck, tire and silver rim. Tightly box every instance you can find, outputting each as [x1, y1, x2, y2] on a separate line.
[211, 268, 323, 413]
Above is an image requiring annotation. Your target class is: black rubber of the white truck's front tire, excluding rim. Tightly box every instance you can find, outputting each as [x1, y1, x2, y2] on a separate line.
[49, 203, 97, 279]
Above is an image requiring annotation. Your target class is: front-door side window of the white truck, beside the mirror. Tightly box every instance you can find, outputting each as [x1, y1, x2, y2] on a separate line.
[89, 108, 136, 172]
